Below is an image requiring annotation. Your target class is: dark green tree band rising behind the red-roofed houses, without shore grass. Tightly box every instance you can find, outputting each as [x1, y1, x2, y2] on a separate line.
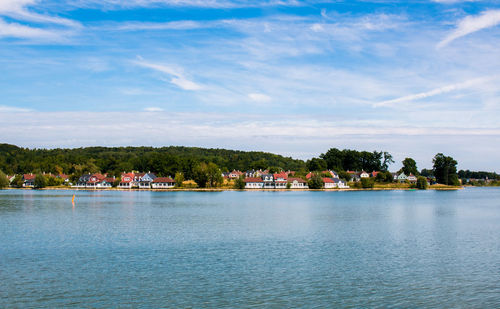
[0, 144, 472, 187]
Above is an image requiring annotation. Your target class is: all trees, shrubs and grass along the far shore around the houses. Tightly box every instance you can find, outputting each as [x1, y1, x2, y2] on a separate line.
[0, 144, 500, 189]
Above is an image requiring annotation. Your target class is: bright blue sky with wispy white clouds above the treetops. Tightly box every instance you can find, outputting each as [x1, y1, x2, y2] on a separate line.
[0, 0, 500, 172]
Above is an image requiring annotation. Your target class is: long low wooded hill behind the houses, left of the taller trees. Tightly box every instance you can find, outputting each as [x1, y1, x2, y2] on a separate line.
[0, 144, 306, 177]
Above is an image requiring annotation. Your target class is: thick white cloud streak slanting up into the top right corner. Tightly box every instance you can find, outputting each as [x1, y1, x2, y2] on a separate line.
[437, 10, 500, 48]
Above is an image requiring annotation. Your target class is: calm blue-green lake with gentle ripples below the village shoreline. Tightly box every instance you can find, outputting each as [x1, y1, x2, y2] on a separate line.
[0, 188, 500, 308]
